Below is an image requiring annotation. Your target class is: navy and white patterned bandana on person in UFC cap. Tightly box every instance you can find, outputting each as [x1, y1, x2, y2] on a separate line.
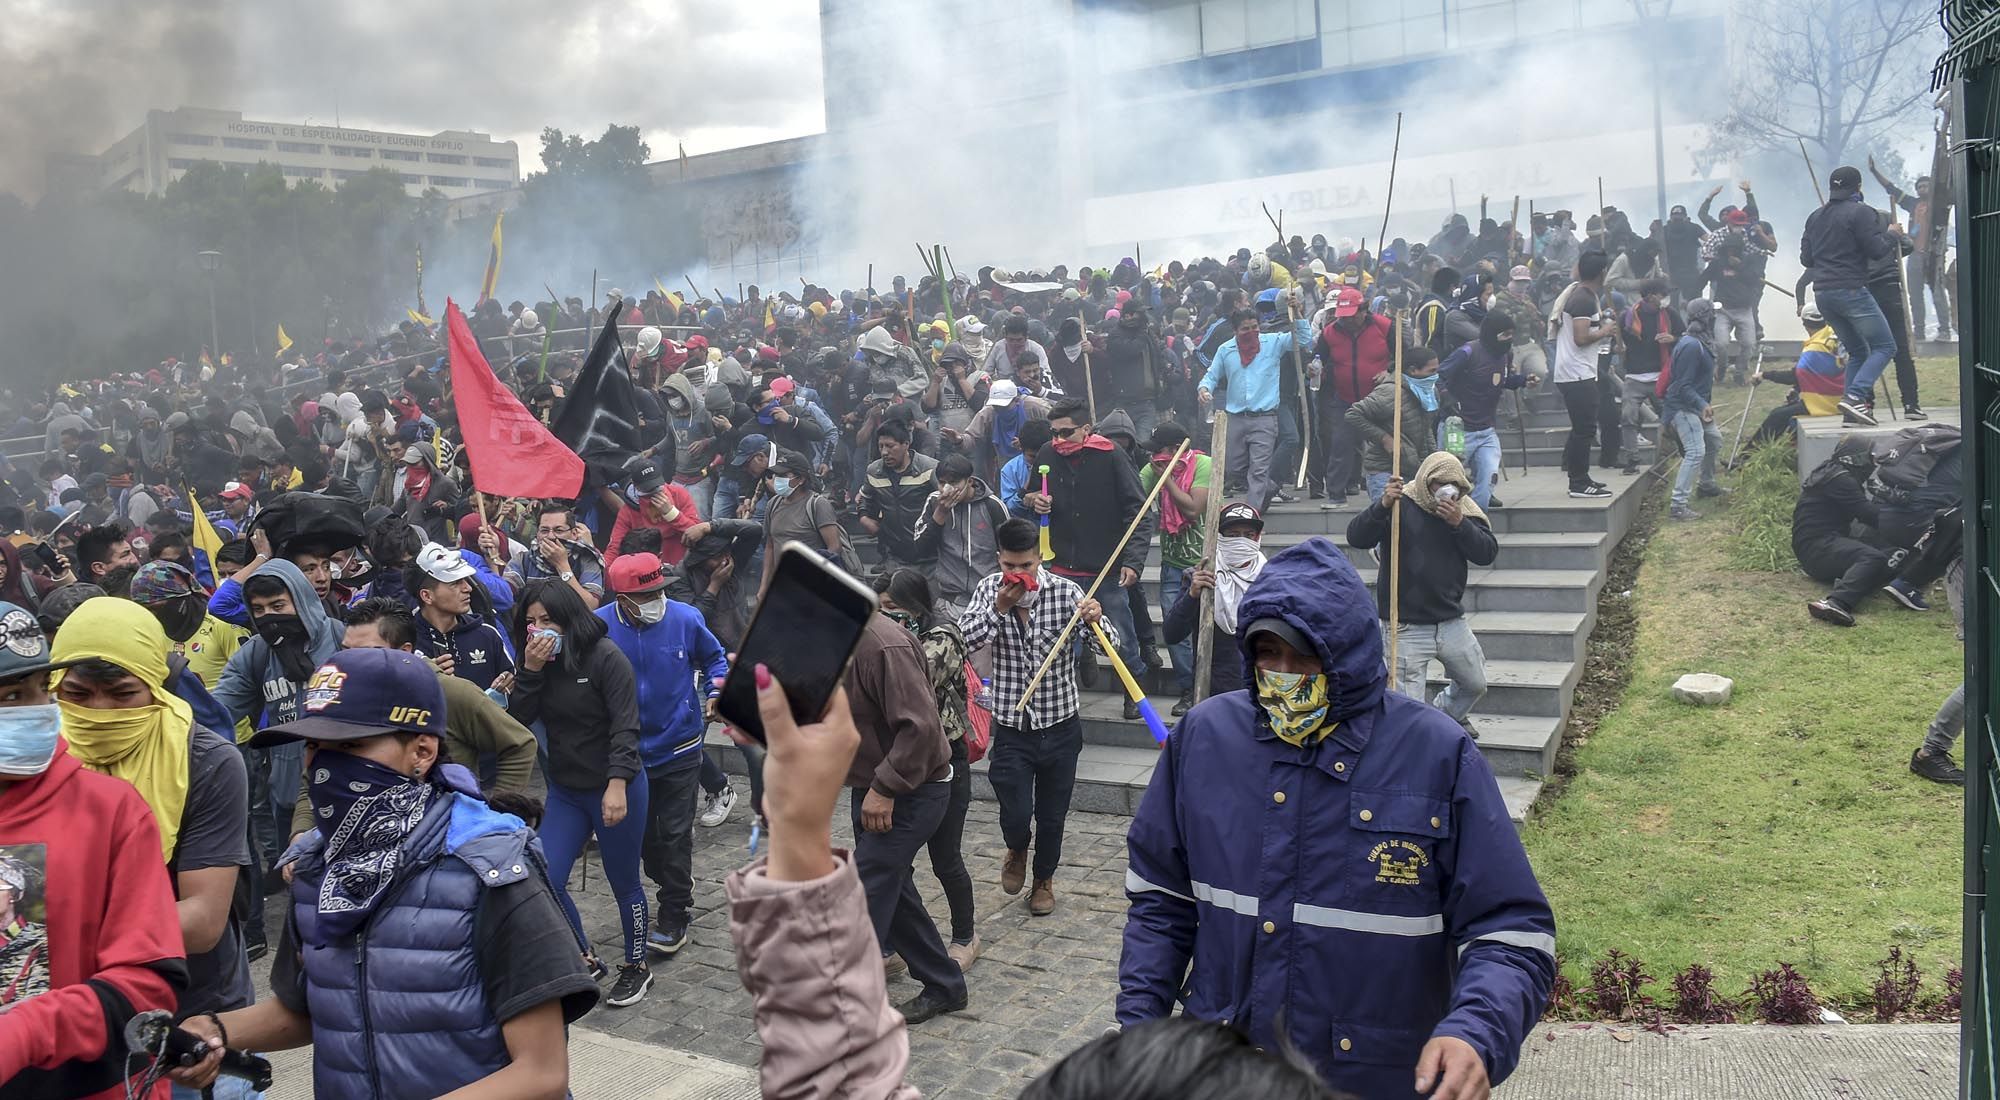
[306, 748, 436, 944]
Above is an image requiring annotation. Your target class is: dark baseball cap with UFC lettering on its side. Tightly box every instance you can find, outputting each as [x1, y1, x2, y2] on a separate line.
[248, 650, 444, 748]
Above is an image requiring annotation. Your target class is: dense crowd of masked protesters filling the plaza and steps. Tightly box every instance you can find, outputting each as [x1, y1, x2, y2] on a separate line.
[0, 160, 1948, 1098]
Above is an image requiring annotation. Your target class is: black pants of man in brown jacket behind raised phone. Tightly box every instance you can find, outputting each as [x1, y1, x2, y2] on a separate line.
[848, 782, 966, 1000]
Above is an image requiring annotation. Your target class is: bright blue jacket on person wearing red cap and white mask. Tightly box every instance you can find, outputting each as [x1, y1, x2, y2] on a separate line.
[596, 600, 730, 774]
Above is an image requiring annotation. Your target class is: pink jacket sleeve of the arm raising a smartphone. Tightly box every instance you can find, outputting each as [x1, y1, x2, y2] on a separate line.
[724, 848, 922, 1100]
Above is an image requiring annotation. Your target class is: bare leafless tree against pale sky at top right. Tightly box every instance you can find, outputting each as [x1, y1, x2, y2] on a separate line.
[1710, 0, 1944, 174]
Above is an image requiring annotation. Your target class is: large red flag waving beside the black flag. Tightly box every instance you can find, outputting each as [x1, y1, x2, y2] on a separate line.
[444, 298, 584, 500]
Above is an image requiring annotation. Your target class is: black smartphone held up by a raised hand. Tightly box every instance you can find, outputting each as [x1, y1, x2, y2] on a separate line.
[716, 540, 876, 744]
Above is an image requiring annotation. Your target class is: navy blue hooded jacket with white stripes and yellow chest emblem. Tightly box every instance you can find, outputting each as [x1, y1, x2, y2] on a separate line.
[1118, 538, 1556, 1100]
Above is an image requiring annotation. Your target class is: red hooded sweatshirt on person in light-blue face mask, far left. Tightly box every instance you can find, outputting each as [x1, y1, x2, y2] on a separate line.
[0, 744, 188, 1100]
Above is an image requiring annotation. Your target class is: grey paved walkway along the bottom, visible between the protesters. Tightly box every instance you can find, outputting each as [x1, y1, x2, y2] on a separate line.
[258, 780, 1958, 1100]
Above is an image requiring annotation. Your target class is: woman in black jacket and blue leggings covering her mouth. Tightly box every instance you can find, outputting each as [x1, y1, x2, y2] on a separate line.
[508, 580, 652, 1008]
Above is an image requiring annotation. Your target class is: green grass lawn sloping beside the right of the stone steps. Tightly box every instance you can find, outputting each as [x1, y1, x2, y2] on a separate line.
[1524, 360, 1964, 1004]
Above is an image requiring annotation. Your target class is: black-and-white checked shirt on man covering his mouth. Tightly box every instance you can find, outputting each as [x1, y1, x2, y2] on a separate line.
[958, 570, 1118, 730]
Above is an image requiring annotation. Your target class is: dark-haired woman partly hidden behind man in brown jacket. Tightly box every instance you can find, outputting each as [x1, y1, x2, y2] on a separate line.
[876, 568, 980, 970]
